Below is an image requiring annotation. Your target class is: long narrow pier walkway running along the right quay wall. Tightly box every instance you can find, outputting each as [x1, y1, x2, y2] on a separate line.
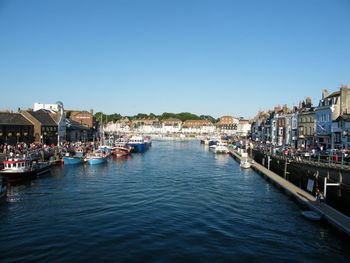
[230, 151, 350, 236]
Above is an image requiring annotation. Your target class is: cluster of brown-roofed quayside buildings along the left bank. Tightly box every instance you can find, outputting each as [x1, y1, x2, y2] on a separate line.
[0, 102, 97, 145]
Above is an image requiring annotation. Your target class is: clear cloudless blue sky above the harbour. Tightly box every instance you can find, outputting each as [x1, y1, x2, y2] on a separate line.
[0, 0, 350, 117]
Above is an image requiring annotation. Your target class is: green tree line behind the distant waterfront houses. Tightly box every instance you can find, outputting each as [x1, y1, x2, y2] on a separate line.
[94, 112, 218, 124]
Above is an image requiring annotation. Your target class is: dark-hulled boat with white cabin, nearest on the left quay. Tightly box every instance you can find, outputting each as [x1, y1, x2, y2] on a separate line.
[0, 155, 51, 183]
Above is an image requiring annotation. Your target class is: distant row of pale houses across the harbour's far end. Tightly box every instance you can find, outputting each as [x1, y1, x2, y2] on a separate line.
[104, 116, 250, 136]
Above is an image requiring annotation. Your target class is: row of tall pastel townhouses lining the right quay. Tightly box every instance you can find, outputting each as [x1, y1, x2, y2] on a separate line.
[251, 85, 350, 149]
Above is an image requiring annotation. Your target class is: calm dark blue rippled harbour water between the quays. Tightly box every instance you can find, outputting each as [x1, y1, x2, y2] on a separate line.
[0, 141, 350, 262]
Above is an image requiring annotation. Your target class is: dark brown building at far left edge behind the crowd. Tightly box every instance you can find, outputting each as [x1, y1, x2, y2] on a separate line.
[0, 112, 34, 145]
